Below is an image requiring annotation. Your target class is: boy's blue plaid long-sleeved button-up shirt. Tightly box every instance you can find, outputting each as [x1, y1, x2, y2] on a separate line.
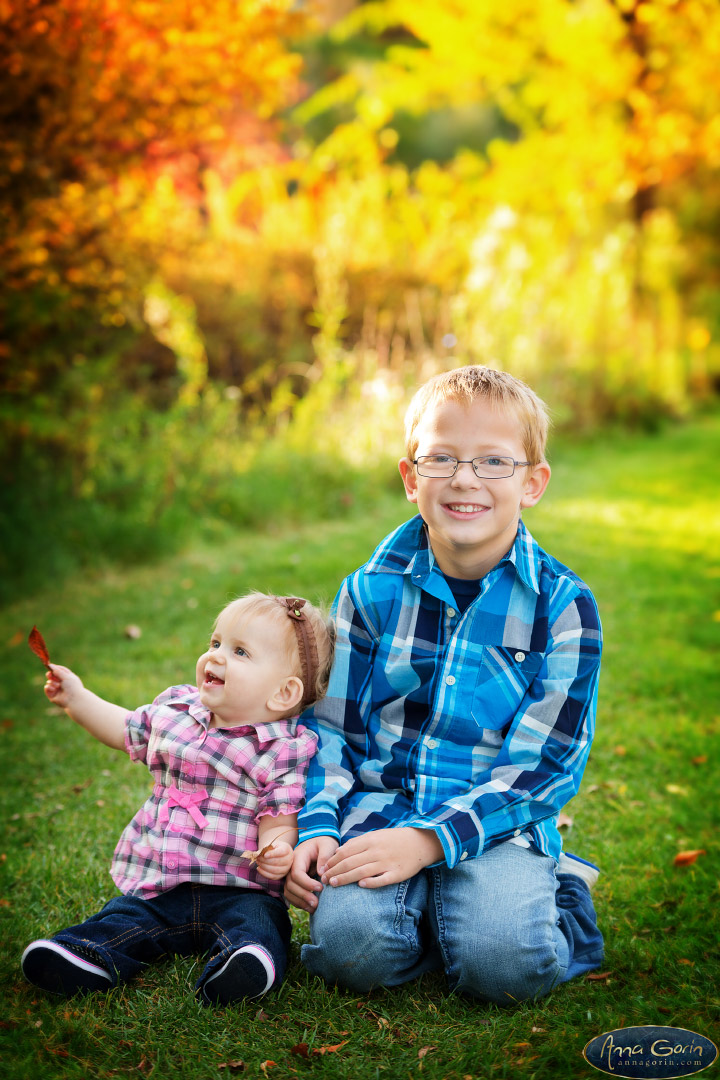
[299, 516, 601, 866]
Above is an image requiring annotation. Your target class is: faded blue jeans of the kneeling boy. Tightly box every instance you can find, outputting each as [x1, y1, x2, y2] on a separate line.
[301, 843, 602, 1005]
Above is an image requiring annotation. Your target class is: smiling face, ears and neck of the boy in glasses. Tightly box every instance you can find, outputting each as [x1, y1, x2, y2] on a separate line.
[399, 397, 549, 579]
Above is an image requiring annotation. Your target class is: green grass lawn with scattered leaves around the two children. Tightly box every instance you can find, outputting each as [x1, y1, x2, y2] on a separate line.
[0, 417, 720, 1080]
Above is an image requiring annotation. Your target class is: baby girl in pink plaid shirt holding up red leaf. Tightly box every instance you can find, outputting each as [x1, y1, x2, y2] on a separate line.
[22, 593, 332, 1004]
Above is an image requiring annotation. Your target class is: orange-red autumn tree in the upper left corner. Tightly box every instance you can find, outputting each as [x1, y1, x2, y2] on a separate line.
[0, 0, 300, 394]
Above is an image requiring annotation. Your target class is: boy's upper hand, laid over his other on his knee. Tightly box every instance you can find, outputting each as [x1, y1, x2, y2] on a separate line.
[321, 826, 444, 889]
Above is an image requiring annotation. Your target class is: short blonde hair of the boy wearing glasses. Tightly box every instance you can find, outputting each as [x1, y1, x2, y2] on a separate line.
[405, 364, 549, 465]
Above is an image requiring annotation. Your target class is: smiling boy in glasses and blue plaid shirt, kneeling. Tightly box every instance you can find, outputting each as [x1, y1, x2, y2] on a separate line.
[285, 366, 602, 1004]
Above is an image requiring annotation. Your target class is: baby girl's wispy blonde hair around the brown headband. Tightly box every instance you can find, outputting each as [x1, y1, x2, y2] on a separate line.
[216, 592, 335, 708]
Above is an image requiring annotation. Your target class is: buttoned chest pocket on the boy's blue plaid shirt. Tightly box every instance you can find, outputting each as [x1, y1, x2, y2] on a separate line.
[471, 645, 544, 730]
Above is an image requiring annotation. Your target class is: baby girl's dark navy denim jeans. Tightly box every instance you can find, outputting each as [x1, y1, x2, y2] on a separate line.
[53, 881, 290, 989]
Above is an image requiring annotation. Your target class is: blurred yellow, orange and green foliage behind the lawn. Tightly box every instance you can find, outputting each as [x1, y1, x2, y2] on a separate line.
[0, 0, 720, 598]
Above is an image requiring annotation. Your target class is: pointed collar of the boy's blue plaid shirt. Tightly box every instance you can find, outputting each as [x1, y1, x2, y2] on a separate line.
[366, 514, 541, 600]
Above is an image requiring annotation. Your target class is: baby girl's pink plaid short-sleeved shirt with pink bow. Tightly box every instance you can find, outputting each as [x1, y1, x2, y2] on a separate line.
[111, 686, 317, 897]
